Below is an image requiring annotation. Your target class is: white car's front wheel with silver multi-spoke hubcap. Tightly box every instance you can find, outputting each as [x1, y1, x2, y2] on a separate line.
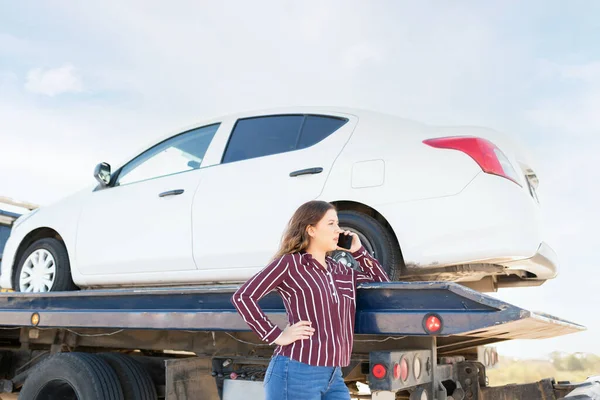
[14, 238, 77, 293]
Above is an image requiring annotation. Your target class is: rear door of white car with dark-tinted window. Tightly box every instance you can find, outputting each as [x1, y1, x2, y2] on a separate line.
[192, 115, 357, 274]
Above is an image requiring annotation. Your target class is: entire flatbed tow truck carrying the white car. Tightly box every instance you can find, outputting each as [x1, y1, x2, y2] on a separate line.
[0, 199, 600, 400]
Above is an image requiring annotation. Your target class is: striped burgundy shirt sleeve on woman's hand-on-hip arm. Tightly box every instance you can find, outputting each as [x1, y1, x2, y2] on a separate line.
[231, 254, 292, 344]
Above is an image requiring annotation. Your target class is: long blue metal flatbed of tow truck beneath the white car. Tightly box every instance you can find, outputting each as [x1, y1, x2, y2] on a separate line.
[0, 282, 585, 342]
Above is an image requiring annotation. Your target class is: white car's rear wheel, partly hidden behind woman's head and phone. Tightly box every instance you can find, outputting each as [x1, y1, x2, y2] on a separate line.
[333, 211, 404, 281]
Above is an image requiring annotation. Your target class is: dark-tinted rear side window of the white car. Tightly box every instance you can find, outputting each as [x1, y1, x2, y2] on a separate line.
[222, 115, 348, 163]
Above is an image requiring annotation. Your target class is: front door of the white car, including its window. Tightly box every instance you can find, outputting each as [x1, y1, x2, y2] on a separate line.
[76, 124, 220, 276]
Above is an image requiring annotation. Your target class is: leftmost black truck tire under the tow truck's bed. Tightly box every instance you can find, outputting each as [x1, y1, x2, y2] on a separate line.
[19, 353, 124, 400]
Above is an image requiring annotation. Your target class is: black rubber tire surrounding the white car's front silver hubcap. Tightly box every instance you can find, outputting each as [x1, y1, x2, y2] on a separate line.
[13, 238, 78, 292]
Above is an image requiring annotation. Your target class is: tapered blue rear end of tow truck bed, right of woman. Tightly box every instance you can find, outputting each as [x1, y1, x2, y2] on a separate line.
[356, 282, 585, 339]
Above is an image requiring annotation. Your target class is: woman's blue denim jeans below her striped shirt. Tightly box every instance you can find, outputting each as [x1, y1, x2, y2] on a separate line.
[264, 355, 350, 400]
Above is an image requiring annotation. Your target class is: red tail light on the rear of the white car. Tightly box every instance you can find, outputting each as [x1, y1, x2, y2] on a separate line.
[423, 136, 521, 186]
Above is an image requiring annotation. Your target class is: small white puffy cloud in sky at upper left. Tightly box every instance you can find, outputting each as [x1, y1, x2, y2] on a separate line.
[25, 64, 83, 96]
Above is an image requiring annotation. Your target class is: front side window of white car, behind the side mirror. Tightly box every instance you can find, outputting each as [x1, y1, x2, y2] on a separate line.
[115, 124, 220, 185]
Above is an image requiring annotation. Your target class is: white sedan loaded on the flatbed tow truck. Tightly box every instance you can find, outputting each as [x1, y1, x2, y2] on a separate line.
[0, 107, 557, 292]
